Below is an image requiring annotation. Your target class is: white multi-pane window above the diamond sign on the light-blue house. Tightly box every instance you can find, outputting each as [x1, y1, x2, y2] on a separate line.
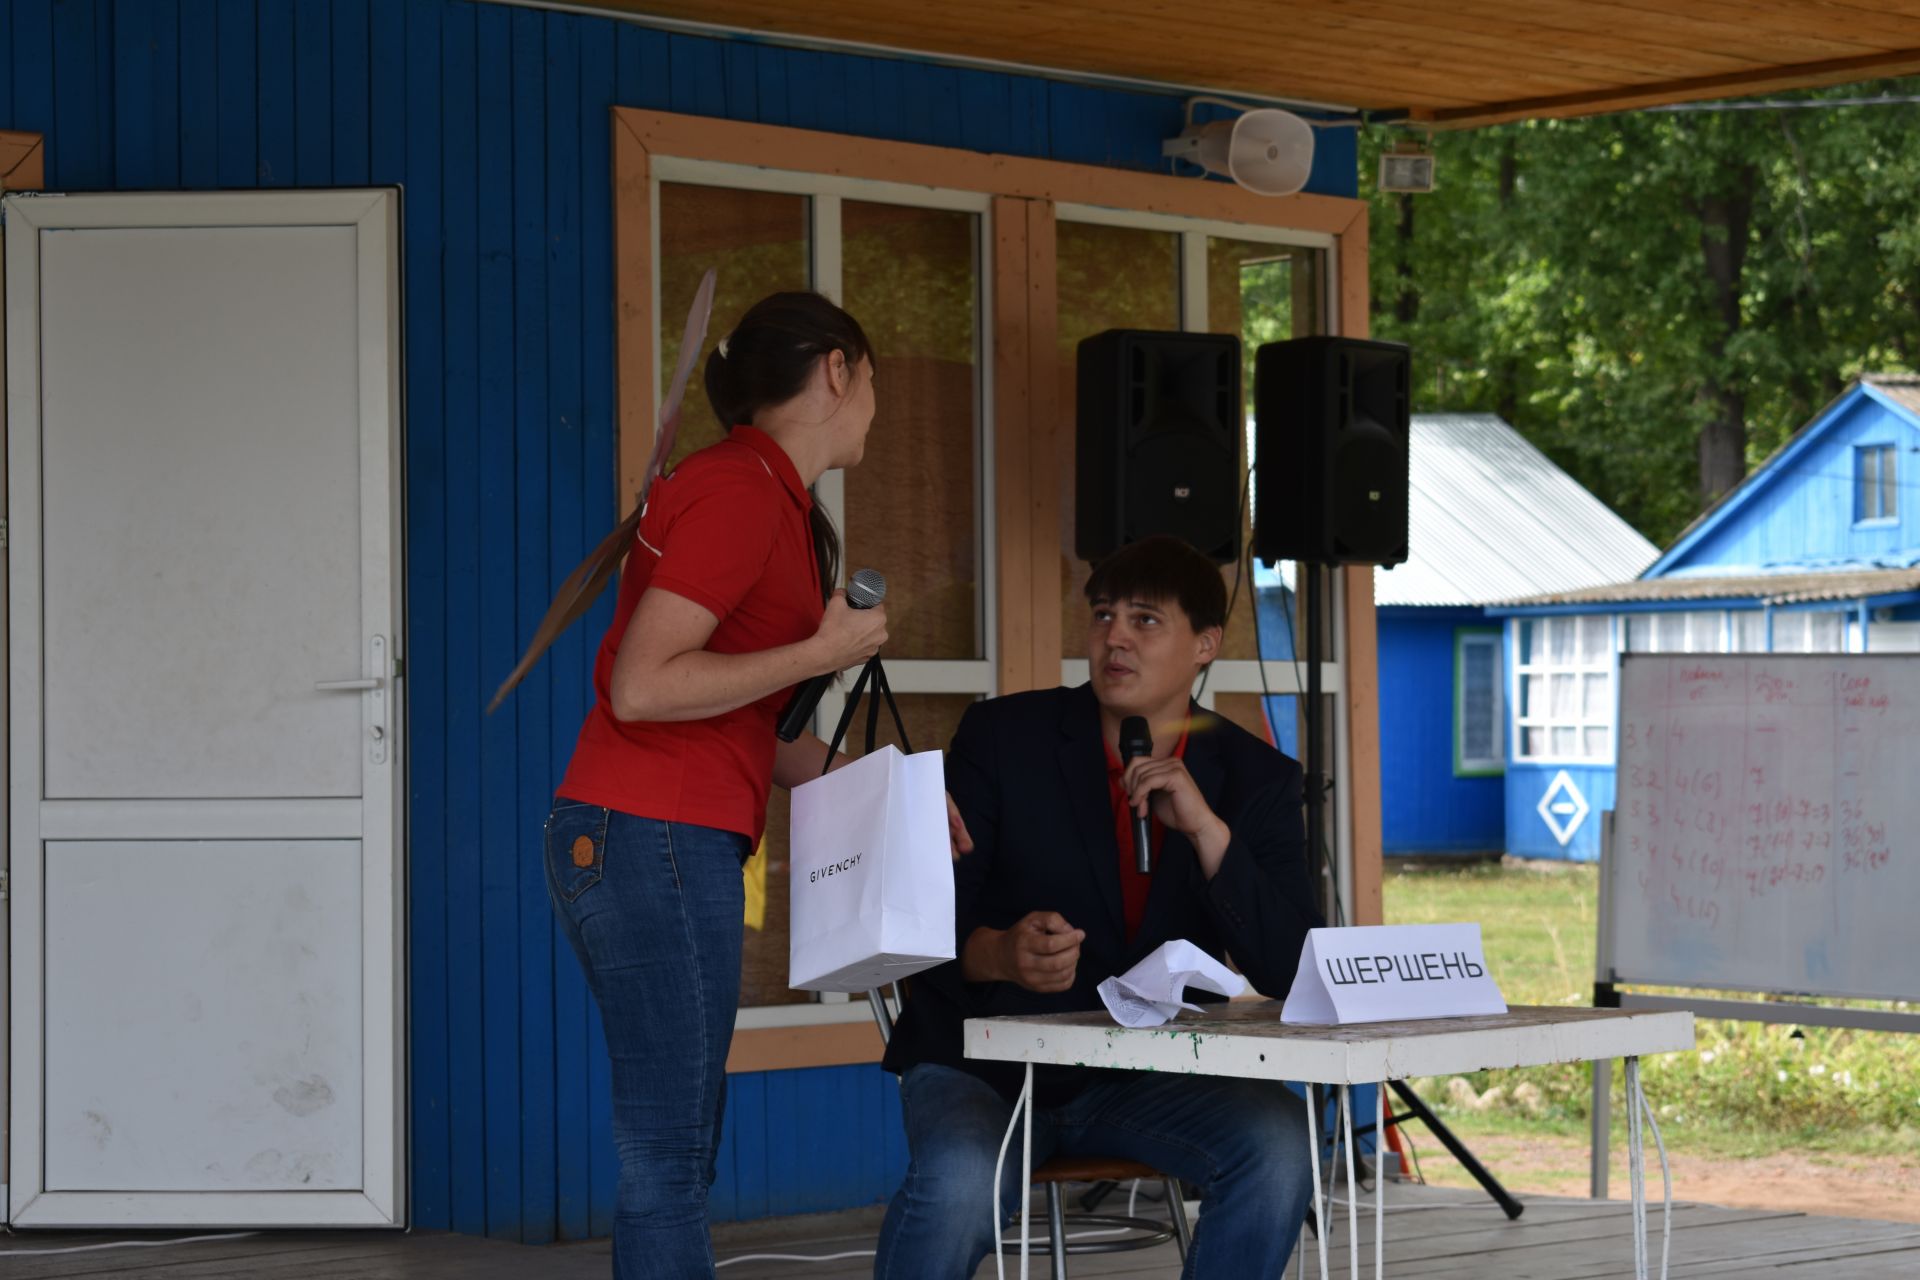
[1515, 618, 1613, 760]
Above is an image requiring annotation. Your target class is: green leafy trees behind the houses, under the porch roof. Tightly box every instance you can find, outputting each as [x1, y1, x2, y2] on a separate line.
[1359, 79, 1920, 545]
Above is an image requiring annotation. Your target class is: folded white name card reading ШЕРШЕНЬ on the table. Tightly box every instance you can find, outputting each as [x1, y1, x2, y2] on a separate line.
[1281, 925, 1507, 1025]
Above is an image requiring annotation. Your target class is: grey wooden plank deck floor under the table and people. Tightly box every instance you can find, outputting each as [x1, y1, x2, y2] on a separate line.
[0, 1186, 1920, 1280]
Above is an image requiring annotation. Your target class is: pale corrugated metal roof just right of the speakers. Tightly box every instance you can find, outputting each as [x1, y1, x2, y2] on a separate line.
[1373, 413, 1659, 604]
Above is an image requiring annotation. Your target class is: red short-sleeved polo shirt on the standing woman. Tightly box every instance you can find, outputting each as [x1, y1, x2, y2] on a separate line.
[561, 426, 824, 841]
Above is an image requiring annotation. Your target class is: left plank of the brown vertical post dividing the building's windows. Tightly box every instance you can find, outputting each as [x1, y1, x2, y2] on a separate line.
[989, 196, 1033, 693]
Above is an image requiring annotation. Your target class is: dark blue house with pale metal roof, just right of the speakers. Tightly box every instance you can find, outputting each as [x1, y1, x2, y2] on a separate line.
[1373, 415, 1657, 856]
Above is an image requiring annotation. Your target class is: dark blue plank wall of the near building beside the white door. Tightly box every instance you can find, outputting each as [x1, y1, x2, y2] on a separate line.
[0, 0, 1356, 1240]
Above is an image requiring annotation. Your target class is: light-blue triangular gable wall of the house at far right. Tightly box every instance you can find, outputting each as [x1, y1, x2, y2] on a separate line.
[1649, 388, 1920, 578]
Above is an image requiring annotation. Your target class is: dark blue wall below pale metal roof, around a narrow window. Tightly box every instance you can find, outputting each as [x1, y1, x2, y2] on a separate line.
[1379, 606, 1507, 856]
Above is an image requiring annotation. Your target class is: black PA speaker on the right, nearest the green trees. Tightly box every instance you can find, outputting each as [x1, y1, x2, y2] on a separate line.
[1254, 338, 1411, 564]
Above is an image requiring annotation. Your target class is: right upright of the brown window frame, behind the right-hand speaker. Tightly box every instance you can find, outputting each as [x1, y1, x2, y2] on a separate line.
[1334, 209, 1386, 925]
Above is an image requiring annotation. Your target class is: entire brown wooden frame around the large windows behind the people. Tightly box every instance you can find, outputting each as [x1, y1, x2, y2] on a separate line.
[612, 107, 1380, 1071]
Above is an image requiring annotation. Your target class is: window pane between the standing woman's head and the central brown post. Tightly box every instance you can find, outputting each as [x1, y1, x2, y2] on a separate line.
[841, 200, 985, 658]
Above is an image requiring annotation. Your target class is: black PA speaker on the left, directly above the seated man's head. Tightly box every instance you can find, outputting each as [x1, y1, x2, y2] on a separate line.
[1073, 328, 1240, 564]
